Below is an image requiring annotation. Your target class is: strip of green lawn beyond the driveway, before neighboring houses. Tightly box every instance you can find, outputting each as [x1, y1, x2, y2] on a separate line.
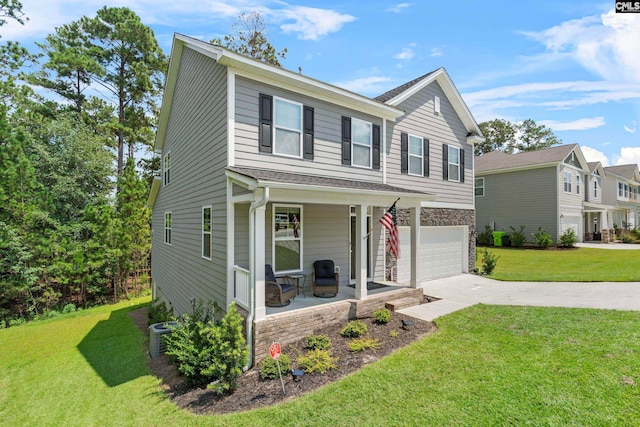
[476, 248, 640, 282]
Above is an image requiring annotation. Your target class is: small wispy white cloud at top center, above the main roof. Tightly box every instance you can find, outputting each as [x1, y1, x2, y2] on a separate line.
[276, 6, 356, 40]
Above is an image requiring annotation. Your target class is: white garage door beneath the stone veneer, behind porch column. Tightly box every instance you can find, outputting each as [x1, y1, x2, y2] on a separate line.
[397, 227, 467, 283]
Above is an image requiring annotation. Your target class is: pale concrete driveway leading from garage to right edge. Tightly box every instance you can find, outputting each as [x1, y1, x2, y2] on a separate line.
[400, 274, 640, 320]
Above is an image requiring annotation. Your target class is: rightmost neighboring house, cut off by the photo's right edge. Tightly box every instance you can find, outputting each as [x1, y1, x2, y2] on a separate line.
[603, 164, 640, 228]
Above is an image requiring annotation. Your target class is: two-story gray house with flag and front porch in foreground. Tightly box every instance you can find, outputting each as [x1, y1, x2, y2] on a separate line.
[148, 35, 482, 357]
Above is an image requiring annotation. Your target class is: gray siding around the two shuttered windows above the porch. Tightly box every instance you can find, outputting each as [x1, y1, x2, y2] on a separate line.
[235, 77, 382, 182]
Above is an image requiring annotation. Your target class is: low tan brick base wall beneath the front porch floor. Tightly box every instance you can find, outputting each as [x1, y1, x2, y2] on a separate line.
[253, 288, 423, 363]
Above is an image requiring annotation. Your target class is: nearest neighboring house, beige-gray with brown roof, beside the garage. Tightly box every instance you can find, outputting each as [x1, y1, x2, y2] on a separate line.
[475, 144, 597, 243]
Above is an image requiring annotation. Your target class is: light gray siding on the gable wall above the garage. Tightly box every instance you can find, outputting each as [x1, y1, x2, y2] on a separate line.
[387, 82, 473, 204]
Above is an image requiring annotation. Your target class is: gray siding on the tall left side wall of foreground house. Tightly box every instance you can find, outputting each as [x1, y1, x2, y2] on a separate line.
[152, 48, 227, 314]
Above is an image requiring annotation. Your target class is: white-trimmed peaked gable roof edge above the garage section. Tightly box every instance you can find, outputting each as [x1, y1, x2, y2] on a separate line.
[375, 67, 484, 142]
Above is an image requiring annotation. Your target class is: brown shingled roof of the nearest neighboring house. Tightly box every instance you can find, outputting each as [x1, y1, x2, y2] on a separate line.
[474, 144, 589, 174]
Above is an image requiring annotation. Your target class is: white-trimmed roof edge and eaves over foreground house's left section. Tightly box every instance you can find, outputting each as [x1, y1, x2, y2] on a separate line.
[154, 33, 404, 153]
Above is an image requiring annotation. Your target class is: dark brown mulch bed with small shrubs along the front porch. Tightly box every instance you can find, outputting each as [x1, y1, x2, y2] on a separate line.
[129, 302, 436, 414]
